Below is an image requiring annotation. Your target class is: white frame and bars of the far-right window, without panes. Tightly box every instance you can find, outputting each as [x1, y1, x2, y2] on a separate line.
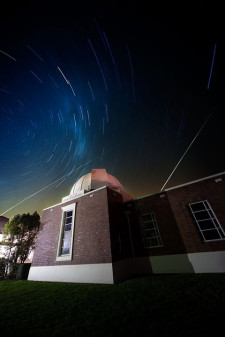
[188, 200, 225, 242]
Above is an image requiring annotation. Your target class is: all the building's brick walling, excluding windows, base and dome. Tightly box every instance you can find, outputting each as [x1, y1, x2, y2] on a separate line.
[32, 175, 225, 266]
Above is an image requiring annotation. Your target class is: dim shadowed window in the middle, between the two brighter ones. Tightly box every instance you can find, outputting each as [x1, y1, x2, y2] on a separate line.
[142, 212, 163, 248]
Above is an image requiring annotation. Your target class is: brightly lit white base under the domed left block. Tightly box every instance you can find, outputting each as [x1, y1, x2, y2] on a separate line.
[28, 263, 113, 284]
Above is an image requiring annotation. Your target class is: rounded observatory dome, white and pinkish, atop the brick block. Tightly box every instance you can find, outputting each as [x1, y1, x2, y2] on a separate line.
[70, 169, 133, 201]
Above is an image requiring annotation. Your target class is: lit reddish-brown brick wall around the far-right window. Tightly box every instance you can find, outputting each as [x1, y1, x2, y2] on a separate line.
[167, 175, 225, 253]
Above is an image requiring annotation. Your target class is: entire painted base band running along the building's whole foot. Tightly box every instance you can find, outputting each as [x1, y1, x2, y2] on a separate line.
[28, 251, 225, 284]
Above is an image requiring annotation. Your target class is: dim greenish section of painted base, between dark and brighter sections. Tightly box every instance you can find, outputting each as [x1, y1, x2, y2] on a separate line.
[149, 254, 194, 274]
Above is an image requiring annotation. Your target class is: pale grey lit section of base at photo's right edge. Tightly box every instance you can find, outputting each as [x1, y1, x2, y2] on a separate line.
[188, 251, 225, 273]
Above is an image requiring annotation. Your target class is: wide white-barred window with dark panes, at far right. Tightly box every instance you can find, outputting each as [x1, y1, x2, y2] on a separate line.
[188, 200, 225, 241]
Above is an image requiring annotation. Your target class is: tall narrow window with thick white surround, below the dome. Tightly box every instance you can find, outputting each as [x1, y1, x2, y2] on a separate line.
[56, 204, 76, 261]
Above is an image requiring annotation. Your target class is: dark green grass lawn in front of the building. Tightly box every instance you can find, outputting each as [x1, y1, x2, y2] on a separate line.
[0, 274, 225, 337]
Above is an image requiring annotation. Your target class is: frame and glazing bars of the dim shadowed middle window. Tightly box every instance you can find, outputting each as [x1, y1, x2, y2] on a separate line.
[141, 212, 163, 248]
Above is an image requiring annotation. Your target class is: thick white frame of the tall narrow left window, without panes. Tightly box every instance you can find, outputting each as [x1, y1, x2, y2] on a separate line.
[56, 203, 76, 261]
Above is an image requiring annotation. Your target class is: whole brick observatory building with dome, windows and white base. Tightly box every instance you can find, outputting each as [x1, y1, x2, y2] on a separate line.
[28, 169, 225, 283]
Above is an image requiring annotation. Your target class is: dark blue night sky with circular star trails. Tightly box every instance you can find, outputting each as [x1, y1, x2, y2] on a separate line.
[0, 1, 225, 217]
